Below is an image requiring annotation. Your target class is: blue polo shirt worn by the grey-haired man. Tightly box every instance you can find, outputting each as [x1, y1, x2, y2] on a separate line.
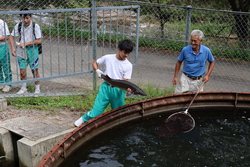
[177, 45, 214, 77]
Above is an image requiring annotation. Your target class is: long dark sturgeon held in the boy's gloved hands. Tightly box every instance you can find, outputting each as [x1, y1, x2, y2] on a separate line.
[101, 74, 147, 96]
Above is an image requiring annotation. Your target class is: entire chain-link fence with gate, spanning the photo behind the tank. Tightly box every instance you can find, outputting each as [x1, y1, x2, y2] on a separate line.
[0, 0, 250, 96]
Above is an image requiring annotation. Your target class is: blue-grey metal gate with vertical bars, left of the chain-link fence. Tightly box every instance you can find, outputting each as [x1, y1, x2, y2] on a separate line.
[0, 6, 140, 97]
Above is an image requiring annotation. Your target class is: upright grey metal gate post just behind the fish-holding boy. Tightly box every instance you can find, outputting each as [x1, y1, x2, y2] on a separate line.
[91, 0, 97, 90]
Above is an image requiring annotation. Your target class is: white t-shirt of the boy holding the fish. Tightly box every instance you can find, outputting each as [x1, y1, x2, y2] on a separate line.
[96, 54, 132, 79]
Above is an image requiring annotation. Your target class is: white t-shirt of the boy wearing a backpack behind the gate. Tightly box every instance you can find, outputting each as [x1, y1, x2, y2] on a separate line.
[11, 21, 42, 43]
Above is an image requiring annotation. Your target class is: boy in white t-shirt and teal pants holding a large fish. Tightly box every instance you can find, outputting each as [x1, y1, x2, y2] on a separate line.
[75, 40, 134, 126]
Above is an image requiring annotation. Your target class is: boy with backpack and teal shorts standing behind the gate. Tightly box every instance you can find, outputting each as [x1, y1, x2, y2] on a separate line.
[10, 9, 42, 94]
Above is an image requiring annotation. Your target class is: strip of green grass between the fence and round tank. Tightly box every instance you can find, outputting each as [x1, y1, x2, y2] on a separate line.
[6, 84, 174, 112]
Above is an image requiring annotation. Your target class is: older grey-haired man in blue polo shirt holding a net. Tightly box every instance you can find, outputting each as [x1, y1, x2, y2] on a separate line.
[172, 30, 215, 94]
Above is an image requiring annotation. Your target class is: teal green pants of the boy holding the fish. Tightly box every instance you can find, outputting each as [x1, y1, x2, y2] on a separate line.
[82, 82, 125, 122]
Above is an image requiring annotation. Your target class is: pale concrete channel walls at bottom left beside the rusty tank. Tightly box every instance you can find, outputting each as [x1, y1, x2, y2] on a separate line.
[0, 128, 74, 167]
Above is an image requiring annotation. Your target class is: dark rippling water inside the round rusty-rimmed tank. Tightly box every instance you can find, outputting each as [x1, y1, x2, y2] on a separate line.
[62, 116, 250, 167]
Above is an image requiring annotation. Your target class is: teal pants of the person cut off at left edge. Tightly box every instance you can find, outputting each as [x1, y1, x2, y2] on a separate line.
[0, 44, 12, 83]
